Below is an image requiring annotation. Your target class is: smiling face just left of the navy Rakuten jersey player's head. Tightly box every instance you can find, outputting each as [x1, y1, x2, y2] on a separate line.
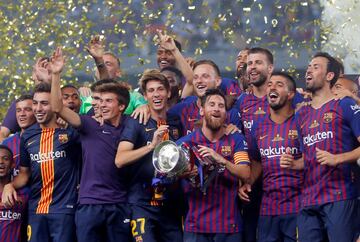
[16, 99, 36, 129]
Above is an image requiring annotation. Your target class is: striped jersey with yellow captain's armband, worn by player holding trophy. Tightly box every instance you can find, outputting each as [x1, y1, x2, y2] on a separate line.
[176, 129, 249, 233]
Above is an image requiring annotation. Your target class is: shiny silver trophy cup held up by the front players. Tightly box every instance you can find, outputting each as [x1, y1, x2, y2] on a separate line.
[152, 140, 190, 177]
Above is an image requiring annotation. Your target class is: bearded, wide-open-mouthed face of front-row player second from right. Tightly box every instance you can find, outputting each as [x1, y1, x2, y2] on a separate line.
[266, 75, 294, 110]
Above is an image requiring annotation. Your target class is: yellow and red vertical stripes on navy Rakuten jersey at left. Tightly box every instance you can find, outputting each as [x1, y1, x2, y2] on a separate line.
[36, 129, 55, 213]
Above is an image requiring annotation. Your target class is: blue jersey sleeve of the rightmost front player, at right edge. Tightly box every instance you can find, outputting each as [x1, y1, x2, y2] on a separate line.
[340, 97, 360, 139]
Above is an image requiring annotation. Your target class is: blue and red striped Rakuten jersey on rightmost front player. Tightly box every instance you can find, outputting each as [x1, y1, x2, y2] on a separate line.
[296, 98, 360, 206]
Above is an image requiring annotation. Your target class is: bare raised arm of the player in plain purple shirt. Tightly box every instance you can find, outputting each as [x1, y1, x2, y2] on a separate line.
[49, 47, 81, 127]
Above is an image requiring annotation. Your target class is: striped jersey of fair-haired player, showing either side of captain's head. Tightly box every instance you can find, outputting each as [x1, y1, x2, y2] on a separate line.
[168, 98, 242, 136]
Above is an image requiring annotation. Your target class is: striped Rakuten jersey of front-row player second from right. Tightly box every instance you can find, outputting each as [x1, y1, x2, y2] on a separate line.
[249, 115, 304, 215]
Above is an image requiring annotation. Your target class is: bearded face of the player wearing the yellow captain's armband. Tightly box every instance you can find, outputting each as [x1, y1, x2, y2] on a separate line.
[200, 95, 226, 131]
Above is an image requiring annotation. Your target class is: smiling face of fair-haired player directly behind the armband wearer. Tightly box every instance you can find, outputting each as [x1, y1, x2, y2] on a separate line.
[193, 64, 221, 97]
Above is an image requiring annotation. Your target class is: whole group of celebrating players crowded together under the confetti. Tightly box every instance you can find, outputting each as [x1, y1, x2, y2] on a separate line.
[0, 32, 360, 242]
